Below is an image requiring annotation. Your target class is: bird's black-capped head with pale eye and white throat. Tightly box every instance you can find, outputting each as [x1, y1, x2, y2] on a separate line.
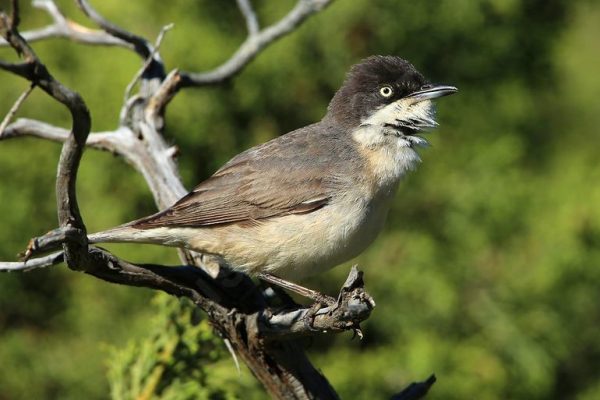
[327, 56, 457, 147]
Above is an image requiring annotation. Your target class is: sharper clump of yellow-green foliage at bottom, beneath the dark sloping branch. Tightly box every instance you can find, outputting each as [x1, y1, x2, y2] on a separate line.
[108, 296, 239, 400]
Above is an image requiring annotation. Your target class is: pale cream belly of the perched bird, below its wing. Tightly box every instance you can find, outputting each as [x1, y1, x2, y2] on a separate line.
[189, 189, 392, 280]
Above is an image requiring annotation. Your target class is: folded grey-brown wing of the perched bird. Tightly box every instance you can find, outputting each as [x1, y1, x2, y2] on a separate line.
[134, 130, 339, 229]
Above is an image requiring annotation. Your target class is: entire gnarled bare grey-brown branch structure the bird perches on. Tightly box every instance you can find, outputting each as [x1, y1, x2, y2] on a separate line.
[0, 0, 404, 399]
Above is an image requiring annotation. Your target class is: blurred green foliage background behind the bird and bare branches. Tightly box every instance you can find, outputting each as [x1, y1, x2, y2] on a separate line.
[0, 0, 600, 399]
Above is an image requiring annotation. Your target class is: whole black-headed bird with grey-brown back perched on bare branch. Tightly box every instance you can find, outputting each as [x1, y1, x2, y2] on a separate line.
[90, 56, 457, 280]
